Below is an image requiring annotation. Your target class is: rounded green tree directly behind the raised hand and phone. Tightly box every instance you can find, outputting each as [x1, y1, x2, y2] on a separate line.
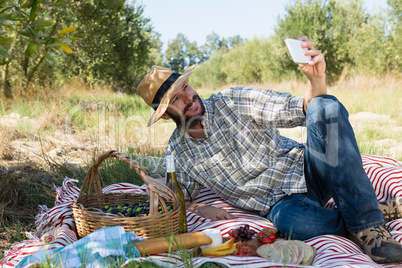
[274, 0, 370, 82]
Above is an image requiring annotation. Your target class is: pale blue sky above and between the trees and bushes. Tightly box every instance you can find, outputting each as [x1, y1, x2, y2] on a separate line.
[136, 0, 387, 50]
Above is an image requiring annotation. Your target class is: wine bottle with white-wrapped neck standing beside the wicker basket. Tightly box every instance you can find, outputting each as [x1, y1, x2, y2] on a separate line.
[166, 155, 187, 233]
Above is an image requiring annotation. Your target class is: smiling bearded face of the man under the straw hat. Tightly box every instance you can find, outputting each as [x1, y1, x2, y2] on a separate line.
[166, 82, 205, 128]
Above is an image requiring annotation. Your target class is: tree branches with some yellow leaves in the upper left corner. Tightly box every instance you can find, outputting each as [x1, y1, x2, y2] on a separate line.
[0, 0, 75, 98]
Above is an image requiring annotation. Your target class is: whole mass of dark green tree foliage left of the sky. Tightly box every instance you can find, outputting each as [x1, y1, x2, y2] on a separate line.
[0, 0, 161, 98]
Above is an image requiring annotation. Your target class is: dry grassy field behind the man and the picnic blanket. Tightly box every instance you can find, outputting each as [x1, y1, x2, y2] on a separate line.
[0, 76, 402, 258]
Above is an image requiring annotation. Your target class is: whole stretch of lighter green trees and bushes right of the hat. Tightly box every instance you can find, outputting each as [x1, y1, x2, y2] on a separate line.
[191, 0, 402, 88]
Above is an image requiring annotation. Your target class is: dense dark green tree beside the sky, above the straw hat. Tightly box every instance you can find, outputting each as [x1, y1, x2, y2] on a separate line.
[56, 0, 161, 93]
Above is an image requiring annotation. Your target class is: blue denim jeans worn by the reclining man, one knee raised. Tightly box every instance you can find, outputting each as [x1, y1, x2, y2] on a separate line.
[267, 95, 385, 240]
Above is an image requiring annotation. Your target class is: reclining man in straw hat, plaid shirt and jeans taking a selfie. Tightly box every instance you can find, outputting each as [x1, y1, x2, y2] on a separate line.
[137, 36, 402, 263]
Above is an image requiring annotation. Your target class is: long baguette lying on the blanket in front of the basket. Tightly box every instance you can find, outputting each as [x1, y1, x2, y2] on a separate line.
[134, 232, 212, 256]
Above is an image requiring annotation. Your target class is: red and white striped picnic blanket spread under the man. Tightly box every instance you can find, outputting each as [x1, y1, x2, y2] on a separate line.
[0, 154, 402, 268]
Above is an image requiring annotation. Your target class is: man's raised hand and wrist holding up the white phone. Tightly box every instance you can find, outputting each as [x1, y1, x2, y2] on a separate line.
[298, 35, 327, 113]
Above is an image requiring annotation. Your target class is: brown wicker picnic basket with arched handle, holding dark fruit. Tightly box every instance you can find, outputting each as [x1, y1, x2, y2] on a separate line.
[71, 151, 180, 238]
